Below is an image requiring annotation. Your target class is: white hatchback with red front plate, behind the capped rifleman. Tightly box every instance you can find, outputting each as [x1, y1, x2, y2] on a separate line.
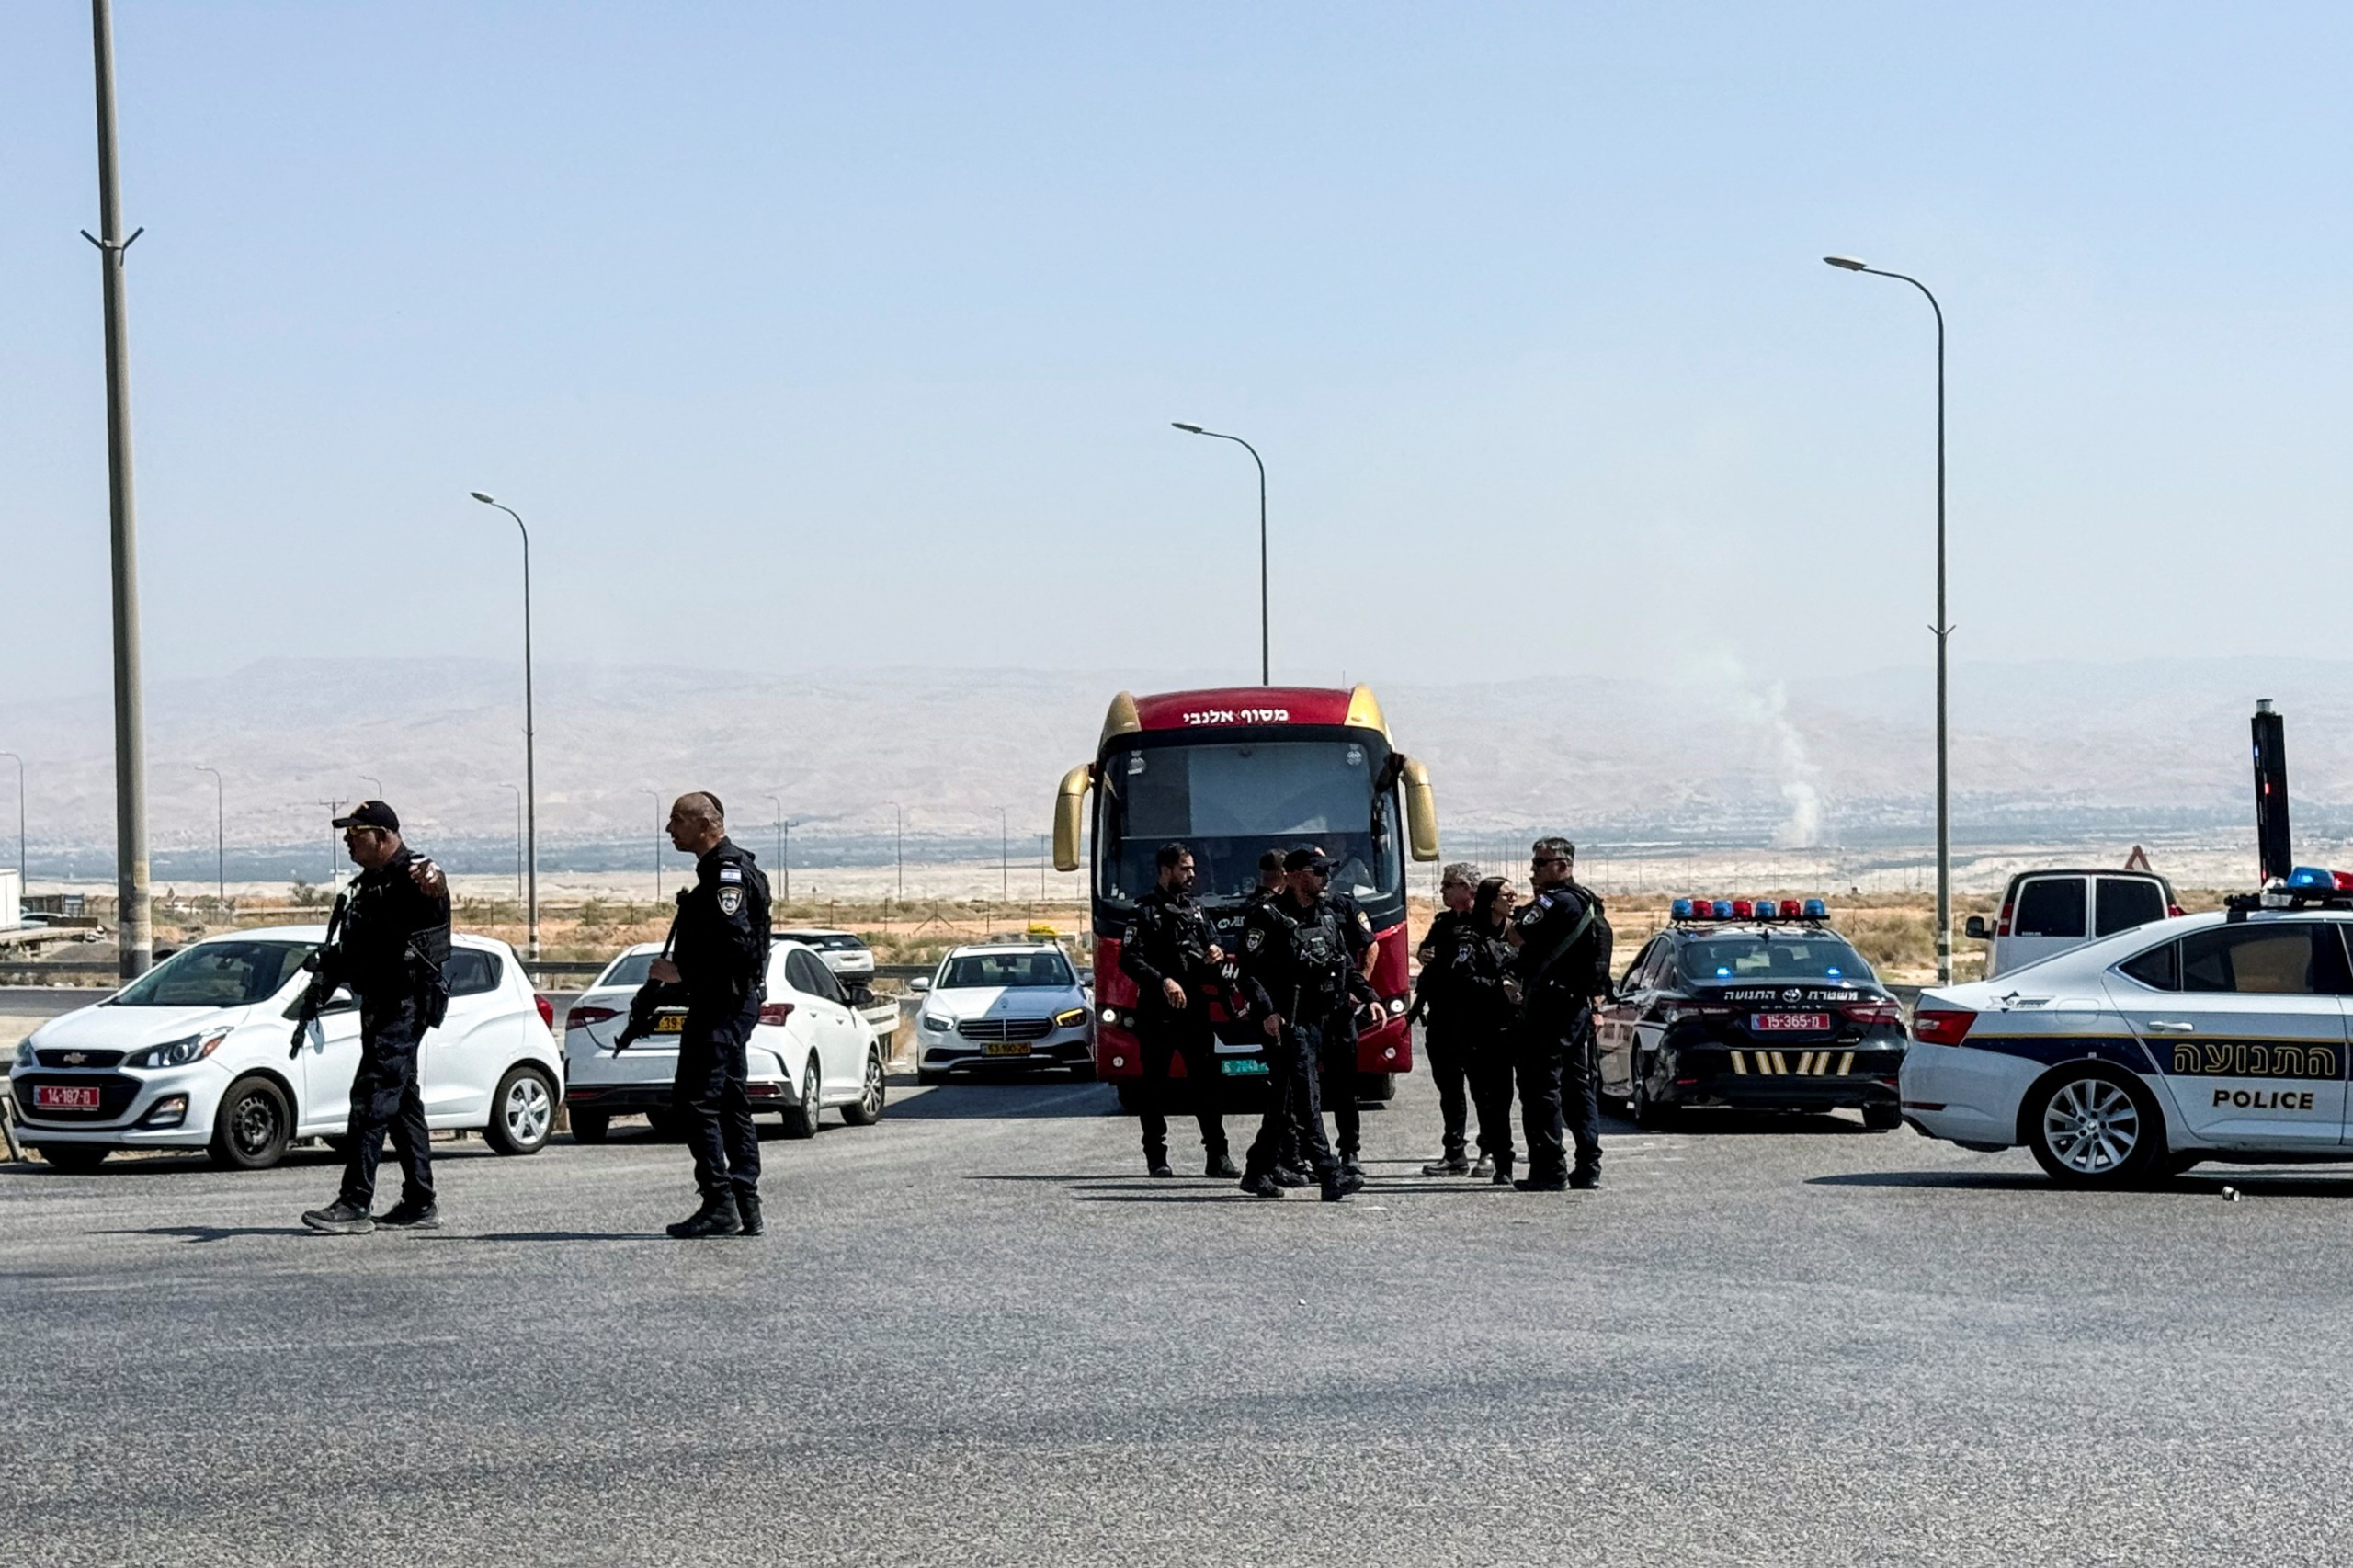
[9, 926, 564, 1170]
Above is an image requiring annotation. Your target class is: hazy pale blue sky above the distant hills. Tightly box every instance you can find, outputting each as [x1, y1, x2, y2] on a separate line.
[0, 0, 2353, 695]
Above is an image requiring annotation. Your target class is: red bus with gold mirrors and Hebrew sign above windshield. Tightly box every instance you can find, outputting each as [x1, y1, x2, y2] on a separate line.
[1054, 685, 1438, 1102]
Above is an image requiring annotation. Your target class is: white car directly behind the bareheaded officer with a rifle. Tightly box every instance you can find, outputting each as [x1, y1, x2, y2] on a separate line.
[564, 942, 885, 1144]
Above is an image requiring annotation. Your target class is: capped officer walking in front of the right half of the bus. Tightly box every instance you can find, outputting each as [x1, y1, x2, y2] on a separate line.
[1243, 850, 1365, 1203]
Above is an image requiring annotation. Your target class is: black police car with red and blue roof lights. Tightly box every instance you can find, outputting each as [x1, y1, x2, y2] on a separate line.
[1593, 900, 1906, 1132]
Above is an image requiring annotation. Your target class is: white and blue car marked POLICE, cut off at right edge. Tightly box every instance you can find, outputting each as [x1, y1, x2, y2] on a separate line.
[1904, 867, 2353, 1187]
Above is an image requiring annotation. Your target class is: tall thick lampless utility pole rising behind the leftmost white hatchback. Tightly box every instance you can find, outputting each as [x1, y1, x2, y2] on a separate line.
[83, 0, 155, 980]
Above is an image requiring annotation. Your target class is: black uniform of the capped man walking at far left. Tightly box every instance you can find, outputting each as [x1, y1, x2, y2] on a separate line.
[318, 846, 449, 1210]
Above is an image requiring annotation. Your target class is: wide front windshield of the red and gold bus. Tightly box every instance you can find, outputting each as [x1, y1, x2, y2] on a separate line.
[1094, 739, 1404, 906]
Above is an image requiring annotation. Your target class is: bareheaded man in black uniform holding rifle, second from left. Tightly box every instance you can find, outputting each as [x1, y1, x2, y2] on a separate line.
[647, 791, 769, 1241]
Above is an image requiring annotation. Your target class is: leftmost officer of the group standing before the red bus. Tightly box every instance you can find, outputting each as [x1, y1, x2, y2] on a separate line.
[1120, 843, 1243, 1177]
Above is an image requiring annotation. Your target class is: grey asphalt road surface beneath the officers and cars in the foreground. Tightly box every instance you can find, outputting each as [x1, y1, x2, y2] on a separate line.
[0, 1054, 2353, 1568]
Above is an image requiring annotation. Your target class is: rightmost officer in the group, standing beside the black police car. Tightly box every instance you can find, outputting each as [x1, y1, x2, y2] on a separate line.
[1511, 838, 1612, 1191]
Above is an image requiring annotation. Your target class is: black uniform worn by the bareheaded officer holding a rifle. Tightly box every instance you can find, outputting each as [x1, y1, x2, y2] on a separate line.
[671, 838, 769, 1203]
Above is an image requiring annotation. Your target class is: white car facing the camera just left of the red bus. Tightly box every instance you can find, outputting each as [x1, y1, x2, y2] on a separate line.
[915, 942, 1094, 1083]
